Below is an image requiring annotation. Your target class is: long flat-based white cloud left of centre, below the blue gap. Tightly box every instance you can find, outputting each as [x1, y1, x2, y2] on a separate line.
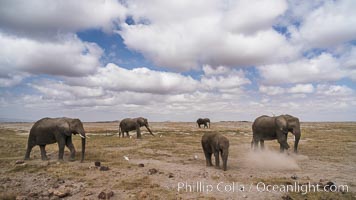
[67, 63, 198, 94]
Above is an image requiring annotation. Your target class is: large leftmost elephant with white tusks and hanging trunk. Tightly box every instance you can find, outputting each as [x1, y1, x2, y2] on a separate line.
[25, 117, 86, 162]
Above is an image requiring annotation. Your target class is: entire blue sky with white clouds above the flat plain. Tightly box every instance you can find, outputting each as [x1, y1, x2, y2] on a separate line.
[0, 0, 356, 121]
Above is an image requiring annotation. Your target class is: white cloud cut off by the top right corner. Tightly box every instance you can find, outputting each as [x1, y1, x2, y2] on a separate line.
[291, 0, 356, 48]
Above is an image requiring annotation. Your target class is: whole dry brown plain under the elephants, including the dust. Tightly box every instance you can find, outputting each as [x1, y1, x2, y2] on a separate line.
[0, 122, 356, 199]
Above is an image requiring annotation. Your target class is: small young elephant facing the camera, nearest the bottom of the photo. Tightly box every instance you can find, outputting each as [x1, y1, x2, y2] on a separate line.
[201, 132, 229, 171]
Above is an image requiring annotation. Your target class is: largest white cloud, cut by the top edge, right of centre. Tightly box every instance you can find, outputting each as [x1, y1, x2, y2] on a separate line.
[117, 0, 298, 71]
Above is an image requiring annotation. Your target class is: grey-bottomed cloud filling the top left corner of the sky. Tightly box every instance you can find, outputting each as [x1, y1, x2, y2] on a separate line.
[0, 0, 126, 35]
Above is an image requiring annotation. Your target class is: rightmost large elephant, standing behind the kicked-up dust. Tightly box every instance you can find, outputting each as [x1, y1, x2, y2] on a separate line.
[251, 115, 301, 153]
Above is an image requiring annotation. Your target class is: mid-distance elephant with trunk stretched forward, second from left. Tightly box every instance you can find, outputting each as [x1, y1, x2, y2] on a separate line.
[119, 117, 154, 139]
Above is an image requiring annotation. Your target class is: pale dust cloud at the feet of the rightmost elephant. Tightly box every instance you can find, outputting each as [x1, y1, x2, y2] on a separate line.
[243, 149, 300, 170]
